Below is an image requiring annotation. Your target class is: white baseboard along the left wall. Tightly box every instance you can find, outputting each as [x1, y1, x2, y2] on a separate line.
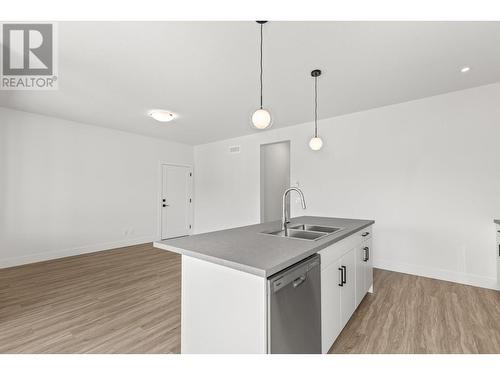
[0, 236, 157, 269]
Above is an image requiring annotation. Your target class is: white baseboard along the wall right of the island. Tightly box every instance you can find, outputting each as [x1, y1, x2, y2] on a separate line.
[373, 259, 500, 290]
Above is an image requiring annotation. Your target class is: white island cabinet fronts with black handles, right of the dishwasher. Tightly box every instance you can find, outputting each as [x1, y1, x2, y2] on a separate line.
[319, 226, 373, 353]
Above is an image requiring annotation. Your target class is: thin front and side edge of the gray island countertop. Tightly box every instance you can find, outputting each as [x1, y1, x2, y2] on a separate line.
[153, 220, 375, 278]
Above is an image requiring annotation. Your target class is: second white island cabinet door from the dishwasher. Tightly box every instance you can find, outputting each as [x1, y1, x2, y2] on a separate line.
[340, 249, 356, 329]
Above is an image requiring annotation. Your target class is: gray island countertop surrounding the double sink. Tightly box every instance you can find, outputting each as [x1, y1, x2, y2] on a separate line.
[154, 216, 374, 277]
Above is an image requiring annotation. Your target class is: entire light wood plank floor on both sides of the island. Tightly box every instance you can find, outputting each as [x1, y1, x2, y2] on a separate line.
[0, 244, 500, 353]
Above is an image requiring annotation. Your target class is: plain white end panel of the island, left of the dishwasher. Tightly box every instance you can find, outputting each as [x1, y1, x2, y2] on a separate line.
[181, 255, 267, 354]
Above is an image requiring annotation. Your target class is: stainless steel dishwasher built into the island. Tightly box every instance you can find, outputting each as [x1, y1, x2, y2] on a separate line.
[267, 254, 321, 354]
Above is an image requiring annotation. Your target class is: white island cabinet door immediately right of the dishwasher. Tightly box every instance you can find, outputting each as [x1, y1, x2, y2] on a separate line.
[321, 261, 341, 353]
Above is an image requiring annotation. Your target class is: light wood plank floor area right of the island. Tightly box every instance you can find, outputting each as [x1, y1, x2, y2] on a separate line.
[330, 269, 500, 354]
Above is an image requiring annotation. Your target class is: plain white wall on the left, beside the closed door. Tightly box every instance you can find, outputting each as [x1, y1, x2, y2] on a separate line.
[0, 108, 193, 267]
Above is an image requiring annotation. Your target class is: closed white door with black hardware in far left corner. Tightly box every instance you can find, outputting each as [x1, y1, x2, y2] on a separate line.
[160, 165, 193, 239]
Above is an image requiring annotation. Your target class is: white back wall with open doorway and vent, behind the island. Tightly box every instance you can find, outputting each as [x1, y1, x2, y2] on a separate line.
[195, 84, 500, 287]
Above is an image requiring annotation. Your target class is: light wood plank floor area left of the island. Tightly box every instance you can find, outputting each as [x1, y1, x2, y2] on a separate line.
[0, 244, 181, 353]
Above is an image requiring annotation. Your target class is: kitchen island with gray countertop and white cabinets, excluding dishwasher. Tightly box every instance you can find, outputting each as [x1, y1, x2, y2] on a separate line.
[154, 216, 374, 353]
